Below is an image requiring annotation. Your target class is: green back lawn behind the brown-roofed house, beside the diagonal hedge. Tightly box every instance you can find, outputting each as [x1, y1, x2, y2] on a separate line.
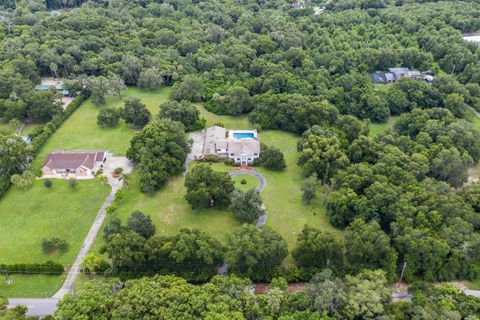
[34, 88, 170, 168]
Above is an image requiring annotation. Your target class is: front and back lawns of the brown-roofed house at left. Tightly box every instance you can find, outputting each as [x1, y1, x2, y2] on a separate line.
[0, 88, 169, 297]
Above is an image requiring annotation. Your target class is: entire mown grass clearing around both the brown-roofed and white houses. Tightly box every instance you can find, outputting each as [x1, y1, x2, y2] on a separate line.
[0, 88, 341, 297]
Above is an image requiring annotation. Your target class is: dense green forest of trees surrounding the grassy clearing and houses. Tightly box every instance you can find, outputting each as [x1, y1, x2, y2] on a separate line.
[0, 0, 480, 319]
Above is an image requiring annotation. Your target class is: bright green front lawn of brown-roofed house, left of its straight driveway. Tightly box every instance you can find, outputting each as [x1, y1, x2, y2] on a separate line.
[0, 180, 109, 297]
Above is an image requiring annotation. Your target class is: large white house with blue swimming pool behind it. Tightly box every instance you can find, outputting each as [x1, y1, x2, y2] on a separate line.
[203, 126, 260, 165]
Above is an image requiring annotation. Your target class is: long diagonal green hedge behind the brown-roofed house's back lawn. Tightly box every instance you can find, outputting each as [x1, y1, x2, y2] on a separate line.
[30, 94, 85, 154]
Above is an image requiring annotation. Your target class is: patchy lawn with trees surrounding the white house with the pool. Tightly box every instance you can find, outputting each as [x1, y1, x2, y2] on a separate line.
[94, 106, 341, 263]
